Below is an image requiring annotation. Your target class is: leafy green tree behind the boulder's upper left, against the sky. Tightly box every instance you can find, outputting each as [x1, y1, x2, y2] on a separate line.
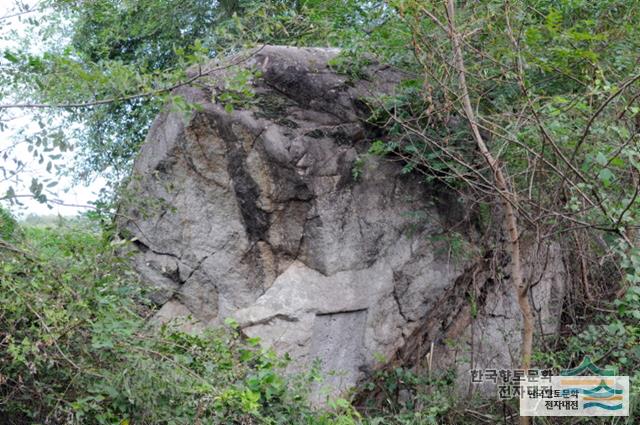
[0, 0, 371, 201]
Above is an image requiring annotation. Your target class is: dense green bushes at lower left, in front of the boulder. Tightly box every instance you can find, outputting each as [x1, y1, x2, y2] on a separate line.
[0, 220, 357, 424]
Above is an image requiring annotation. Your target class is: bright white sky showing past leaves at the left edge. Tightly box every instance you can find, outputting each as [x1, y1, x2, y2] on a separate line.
[0, 0, 106, 216]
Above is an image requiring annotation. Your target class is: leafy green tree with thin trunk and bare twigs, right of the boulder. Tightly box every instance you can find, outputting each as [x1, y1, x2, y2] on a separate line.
[350, 1, 640, 423]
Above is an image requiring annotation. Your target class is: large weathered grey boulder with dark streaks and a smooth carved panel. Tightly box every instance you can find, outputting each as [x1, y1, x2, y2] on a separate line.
[120, 46, 564, 398]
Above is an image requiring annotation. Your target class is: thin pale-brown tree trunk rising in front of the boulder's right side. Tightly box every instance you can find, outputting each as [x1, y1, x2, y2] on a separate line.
[447, 0, 533, 425]
